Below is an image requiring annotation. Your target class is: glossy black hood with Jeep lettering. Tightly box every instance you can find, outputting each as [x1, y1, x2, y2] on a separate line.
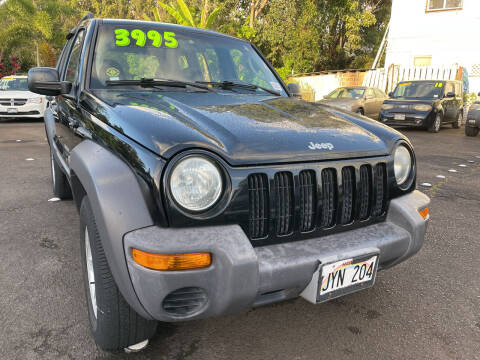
[86, 89, 401, 165]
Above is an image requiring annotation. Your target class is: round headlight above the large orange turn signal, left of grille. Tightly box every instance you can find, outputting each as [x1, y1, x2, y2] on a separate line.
[170, 156, 222, 211]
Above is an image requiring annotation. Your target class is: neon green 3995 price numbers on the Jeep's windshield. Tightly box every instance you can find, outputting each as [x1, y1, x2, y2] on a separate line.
[114, 29, 178, 49]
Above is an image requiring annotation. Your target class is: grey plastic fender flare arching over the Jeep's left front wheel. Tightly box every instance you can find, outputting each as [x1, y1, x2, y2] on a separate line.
[70, 140, 154, 319]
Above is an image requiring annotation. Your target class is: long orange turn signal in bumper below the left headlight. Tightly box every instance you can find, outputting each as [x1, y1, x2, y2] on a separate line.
[132, 249, 212, 271]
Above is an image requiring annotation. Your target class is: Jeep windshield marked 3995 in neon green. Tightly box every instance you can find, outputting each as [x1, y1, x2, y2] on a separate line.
[90, 23, 287, 96]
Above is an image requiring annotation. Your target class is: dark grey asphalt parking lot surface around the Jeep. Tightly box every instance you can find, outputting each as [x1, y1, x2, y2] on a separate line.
[0, 121, 480, 360]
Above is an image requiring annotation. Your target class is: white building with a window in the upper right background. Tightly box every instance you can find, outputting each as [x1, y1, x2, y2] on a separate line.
[385, 0, 480, 92]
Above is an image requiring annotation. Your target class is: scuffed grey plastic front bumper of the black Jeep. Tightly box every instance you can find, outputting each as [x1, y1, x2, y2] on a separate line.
[124, 191, 430, 322]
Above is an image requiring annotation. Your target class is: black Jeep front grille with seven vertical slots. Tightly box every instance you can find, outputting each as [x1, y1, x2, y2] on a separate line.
[248, 162, 387, 240]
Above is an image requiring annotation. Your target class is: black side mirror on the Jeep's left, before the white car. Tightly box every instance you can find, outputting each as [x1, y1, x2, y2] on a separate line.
[28, 67, 72, 96]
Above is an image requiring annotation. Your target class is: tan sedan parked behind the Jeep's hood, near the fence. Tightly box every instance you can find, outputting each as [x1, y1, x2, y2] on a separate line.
[320, 86, 388, 120]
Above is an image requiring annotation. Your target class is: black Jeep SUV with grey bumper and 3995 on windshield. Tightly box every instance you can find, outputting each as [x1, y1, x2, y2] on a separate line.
[28, 16, 429, 350]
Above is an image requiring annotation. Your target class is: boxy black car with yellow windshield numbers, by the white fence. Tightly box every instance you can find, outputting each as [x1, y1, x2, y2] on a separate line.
[380, 80, 463, 133]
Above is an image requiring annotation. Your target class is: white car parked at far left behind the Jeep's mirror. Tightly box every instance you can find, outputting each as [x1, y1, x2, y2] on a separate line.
[0, 75, 47, 119]
